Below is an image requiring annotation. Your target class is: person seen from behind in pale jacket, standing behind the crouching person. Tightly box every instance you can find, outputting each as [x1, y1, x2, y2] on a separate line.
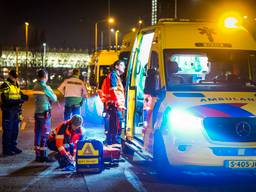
[58, 69, 87, 120]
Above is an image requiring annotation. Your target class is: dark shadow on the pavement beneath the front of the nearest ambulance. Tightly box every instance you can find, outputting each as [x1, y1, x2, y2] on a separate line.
[124, 156, 256, 191]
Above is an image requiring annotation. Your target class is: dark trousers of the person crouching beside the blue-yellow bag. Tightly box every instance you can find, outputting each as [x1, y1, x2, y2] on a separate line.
[47, 140, 74, 168]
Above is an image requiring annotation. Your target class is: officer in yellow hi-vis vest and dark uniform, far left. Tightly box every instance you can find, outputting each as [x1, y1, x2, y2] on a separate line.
[0, 70, 28, 155]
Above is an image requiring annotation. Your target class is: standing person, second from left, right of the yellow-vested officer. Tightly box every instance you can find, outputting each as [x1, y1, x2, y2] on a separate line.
[34, 69, 57, 162]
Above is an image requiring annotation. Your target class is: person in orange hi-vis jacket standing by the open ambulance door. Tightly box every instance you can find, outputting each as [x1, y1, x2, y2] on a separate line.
[106, 60, 125, 145]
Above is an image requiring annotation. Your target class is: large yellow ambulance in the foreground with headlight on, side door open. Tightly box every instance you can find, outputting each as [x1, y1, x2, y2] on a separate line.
[122, 19, 256, 172]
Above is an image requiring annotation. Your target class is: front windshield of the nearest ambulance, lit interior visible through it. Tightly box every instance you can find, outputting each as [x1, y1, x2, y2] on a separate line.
[164, 49, 256, 91]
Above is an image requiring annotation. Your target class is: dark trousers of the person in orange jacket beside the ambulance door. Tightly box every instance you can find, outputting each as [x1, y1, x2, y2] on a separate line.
[106, 105, 123, 145]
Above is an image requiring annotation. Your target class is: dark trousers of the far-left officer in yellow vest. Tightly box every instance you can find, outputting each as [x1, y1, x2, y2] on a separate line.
[2, 108, 20, 153]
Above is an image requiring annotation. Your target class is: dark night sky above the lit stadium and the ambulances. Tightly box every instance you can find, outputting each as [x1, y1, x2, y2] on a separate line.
[0, 0, 256, 50]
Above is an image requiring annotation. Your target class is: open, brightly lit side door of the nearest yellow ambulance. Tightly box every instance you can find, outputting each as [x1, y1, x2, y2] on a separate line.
[126, 30, 155, 142]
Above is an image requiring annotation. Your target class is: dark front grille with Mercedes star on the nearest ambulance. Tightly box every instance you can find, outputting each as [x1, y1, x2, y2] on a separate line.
[203, 117, 256, 142]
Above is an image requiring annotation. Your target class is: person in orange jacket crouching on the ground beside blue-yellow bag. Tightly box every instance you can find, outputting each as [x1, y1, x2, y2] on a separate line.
[47, 115, 83, 171]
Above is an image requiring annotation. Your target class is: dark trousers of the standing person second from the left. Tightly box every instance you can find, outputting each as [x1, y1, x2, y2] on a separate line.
[34, 112, 51, 158]
